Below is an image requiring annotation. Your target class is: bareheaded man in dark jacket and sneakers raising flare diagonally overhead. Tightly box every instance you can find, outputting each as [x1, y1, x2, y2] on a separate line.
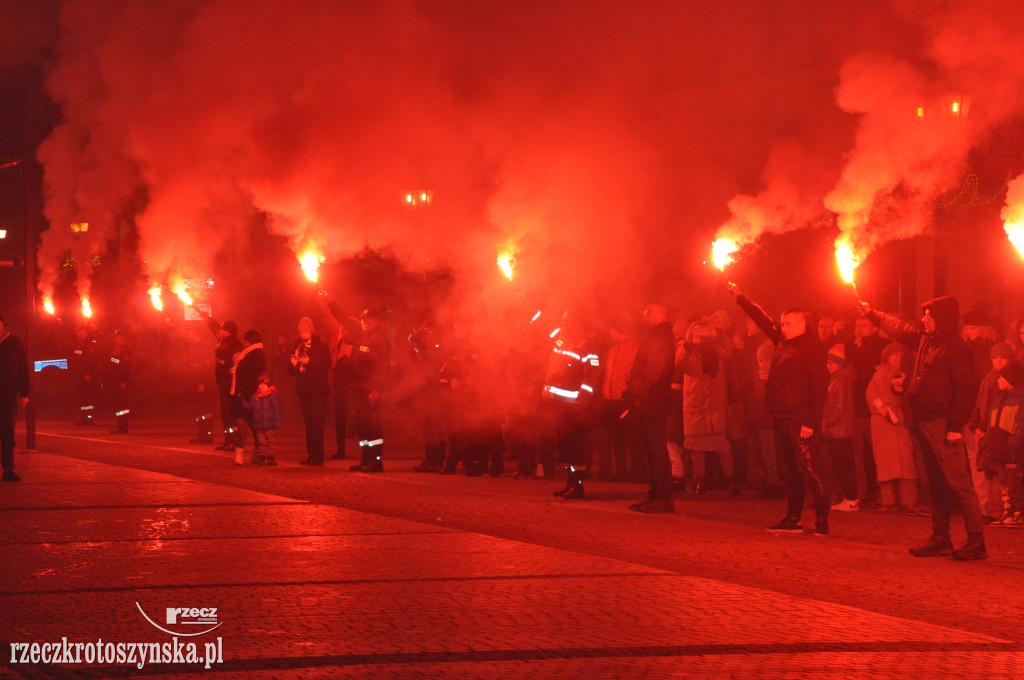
[729, 282, 829, 536]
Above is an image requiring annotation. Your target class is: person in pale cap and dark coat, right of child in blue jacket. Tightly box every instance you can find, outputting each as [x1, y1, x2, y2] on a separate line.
[288, 316, 331, 465]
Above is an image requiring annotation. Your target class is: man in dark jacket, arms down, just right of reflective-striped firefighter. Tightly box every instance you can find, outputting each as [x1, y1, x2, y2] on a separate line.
[623, 302, 676, 513]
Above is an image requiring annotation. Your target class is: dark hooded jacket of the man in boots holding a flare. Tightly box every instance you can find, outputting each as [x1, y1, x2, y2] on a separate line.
[869, 296, 978, 432]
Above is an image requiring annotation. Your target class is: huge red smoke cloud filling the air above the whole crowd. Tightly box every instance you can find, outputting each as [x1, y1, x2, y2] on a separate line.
[39, 0, 1007, 319]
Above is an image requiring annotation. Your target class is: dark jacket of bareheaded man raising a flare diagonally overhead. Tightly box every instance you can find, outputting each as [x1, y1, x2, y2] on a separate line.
[736, 295, 828, 430]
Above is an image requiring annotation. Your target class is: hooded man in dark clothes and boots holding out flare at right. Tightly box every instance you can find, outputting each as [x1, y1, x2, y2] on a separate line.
[861, 296, 988, 559]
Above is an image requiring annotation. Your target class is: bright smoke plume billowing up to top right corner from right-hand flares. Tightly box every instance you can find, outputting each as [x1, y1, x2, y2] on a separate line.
[719, 1, 1024, 274]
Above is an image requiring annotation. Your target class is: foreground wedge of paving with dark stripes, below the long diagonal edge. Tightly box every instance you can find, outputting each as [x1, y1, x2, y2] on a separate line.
[0, 454, 1024, 679]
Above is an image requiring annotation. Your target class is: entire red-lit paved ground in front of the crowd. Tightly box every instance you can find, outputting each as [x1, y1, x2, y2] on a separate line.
[0, 425, 1024, 680]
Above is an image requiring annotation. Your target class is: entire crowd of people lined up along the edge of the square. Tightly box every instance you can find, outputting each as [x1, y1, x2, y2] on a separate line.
[0, 284, 1024, 559]
